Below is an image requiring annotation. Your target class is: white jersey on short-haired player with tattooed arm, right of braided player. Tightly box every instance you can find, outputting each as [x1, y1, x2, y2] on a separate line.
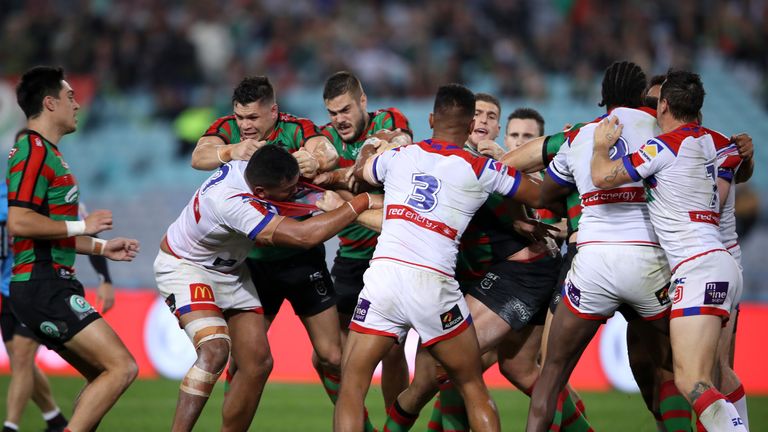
[623, 123, 725, 273]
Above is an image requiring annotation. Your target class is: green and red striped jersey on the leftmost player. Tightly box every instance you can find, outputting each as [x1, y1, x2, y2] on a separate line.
[7, 131, 79, 282]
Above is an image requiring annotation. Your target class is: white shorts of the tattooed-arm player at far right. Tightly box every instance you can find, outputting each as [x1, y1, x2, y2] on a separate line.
[669, 250, 742, 320]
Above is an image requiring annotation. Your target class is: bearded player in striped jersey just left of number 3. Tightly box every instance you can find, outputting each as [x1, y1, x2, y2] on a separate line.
[314, 71, 413, 407]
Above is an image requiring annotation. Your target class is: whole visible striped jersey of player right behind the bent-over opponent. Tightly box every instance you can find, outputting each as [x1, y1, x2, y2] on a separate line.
[203, 112, 320, 261]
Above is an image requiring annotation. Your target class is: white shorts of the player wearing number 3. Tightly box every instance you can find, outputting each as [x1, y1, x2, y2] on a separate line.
[349, 261, 472, 346]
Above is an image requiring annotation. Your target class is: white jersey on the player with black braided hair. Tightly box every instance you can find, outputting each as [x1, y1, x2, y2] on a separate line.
[547, 108, 661, 246]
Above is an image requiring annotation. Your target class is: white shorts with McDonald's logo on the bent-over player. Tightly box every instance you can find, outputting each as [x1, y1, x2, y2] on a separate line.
[154, 251, 263, 317]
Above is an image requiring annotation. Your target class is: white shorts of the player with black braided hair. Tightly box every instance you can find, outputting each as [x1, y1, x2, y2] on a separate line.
[562, 244, 670, 321]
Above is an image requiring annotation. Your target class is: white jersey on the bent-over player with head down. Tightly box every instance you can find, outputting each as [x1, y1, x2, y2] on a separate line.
[167, 161, 276, 273]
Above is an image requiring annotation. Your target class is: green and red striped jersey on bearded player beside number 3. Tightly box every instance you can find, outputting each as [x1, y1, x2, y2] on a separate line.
[322, 108, 413, 260]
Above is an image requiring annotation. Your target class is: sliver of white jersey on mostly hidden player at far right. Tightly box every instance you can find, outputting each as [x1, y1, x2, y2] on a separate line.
[704, 128, 741, 250]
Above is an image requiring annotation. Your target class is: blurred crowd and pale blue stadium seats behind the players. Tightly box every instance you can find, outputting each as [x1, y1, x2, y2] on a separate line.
[0, 0, 768, 301]
